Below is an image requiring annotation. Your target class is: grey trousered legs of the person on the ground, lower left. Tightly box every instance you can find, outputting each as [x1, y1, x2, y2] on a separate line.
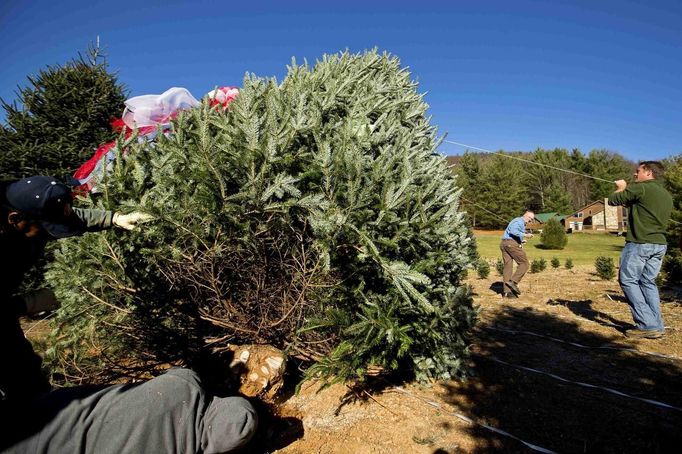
[3, 368, 258, 454]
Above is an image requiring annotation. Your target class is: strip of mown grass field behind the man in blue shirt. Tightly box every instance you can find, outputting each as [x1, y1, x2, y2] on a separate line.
[474, 231, 625, 265]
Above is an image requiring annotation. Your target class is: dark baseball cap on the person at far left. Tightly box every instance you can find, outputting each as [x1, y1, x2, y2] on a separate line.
[5, 175, 80, 238]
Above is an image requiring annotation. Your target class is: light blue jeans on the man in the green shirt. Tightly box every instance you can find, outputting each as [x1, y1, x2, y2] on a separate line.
[618, 242, 667, 330]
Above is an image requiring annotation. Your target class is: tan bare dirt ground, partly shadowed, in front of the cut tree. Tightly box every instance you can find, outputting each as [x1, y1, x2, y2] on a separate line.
[266, 266, 682, 454]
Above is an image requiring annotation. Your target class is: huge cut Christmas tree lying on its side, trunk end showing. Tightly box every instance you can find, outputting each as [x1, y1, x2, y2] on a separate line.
[48, 52, 476, 386]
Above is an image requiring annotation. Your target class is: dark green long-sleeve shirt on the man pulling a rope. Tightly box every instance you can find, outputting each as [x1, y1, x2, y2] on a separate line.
[609, 180, 673, 244]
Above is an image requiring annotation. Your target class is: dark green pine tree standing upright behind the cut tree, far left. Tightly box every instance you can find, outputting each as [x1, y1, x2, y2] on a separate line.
[0, 43, 126, 179]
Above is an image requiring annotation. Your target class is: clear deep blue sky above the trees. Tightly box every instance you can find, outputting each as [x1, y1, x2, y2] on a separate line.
[0, 0, 682, 160]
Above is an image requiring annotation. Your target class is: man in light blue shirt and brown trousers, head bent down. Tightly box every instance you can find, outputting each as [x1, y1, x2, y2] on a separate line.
[500, 210, 535, 298]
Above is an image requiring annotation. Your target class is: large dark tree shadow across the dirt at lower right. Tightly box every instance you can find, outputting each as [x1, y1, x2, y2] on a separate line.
[440, 306, 682, 453]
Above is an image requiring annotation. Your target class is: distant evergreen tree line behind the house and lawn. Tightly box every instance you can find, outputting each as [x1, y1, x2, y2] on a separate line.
[450, 148, 636, 229]
